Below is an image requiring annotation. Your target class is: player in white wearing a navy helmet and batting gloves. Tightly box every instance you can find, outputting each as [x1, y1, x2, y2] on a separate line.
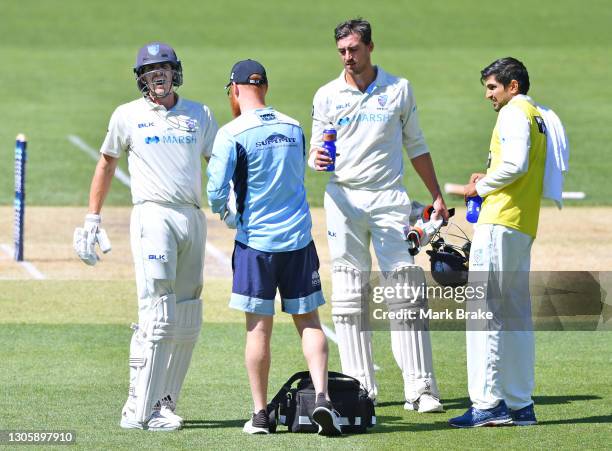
[74, 42, 217, 431]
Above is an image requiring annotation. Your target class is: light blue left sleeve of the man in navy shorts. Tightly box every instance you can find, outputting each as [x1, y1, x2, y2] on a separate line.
[206, 130, 236, 216]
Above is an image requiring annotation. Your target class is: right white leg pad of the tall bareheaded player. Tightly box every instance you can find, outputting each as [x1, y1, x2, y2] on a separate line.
[387, 265, 439, 402]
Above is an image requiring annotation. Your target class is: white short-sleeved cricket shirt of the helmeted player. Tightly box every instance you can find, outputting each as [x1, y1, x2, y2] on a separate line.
[100, 97, 217, 207]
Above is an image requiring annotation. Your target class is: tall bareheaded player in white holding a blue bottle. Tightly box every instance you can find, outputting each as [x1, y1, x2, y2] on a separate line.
[309, 19, 448, 412]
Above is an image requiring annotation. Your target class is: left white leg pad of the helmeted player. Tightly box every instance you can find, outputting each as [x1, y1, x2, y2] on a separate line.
[123, 294, 176, 423]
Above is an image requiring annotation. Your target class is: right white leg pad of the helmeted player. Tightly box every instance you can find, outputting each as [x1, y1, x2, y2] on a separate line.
[163, 299, 202, 407]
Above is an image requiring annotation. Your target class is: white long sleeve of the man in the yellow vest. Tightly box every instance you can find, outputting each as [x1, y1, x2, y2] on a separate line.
[476, 105, 530, 197]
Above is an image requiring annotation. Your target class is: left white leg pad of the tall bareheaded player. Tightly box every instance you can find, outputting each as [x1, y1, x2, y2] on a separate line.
[332, 266, 378, 399]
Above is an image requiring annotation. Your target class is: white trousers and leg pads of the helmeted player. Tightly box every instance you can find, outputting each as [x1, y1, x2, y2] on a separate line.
[124, 202, 206, 423]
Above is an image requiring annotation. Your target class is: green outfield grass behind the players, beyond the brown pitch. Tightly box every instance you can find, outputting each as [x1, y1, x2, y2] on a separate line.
[0, 0, 612, 205]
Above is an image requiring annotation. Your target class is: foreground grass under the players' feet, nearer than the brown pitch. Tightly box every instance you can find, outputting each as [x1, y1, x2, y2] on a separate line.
[0, 279, 612, 449]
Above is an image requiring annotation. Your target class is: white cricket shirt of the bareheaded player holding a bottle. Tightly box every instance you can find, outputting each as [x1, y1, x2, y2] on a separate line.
[310, 67, 429, 190]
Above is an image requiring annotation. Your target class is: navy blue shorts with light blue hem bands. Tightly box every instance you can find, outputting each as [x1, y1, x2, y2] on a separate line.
[230, 241, 325, 315]
